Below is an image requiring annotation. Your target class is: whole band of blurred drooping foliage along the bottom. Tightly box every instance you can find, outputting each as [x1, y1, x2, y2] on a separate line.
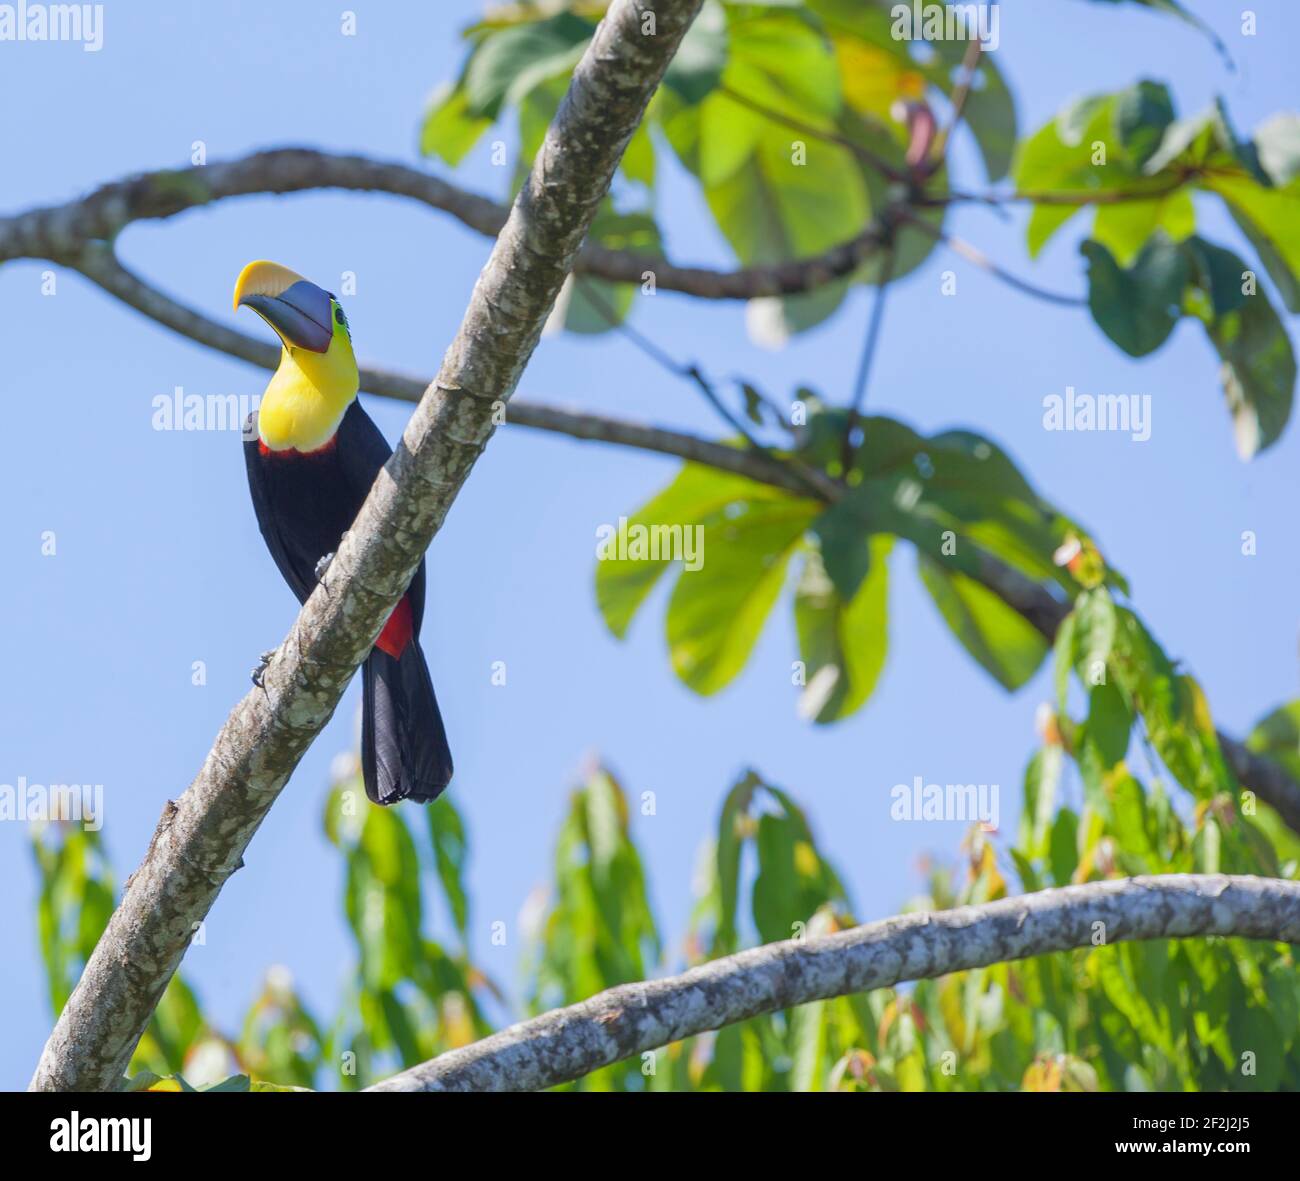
[35, 702, 1300, 1091]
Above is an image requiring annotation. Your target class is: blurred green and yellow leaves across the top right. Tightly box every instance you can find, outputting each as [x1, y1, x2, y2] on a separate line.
[420, 0, 1300, 458]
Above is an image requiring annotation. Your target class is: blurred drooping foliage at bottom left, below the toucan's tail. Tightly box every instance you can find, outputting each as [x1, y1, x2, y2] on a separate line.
[34, 760, 502, 1090]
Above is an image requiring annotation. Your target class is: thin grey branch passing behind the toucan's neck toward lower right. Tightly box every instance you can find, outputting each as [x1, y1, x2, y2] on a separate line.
[63, 243, 1300, 832]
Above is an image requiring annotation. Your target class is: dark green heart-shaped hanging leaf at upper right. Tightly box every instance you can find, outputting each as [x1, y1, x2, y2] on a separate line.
[1082, 237, 1188, 356]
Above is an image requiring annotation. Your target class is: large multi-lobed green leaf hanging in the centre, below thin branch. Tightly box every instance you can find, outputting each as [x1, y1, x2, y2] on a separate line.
[595, 400, 1127, 723]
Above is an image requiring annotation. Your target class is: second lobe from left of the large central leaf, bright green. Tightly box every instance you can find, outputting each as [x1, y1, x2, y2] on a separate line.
[667, 499, 816, 696]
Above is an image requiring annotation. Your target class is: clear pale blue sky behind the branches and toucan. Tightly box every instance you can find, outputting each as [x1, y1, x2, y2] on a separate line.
[0, 0, 1300, 1087]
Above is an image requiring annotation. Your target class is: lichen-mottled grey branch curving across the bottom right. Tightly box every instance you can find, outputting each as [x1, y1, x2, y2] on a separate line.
[369, 874, 1300, 1091]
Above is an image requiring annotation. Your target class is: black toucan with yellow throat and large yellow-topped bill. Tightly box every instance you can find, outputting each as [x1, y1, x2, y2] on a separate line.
[234, 260, 451, 804]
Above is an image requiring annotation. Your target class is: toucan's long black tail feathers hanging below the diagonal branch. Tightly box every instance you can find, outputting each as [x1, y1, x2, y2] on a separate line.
[361, 639, 451, 804]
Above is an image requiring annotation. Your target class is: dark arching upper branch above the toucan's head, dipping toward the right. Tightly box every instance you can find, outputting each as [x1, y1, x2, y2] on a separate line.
[0, 148, 883, 299]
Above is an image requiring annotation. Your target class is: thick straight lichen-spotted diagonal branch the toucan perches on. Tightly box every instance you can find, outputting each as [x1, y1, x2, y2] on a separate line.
[31, 0, 702, 1090]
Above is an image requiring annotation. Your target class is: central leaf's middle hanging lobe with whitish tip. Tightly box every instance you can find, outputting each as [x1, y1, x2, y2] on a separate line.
[794, 536, 893, 724]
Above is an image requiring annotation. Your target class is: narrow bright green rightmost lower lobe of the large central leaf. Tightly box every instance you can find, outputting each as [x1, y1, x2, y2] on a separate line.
[917, 553, 1048, 689]
